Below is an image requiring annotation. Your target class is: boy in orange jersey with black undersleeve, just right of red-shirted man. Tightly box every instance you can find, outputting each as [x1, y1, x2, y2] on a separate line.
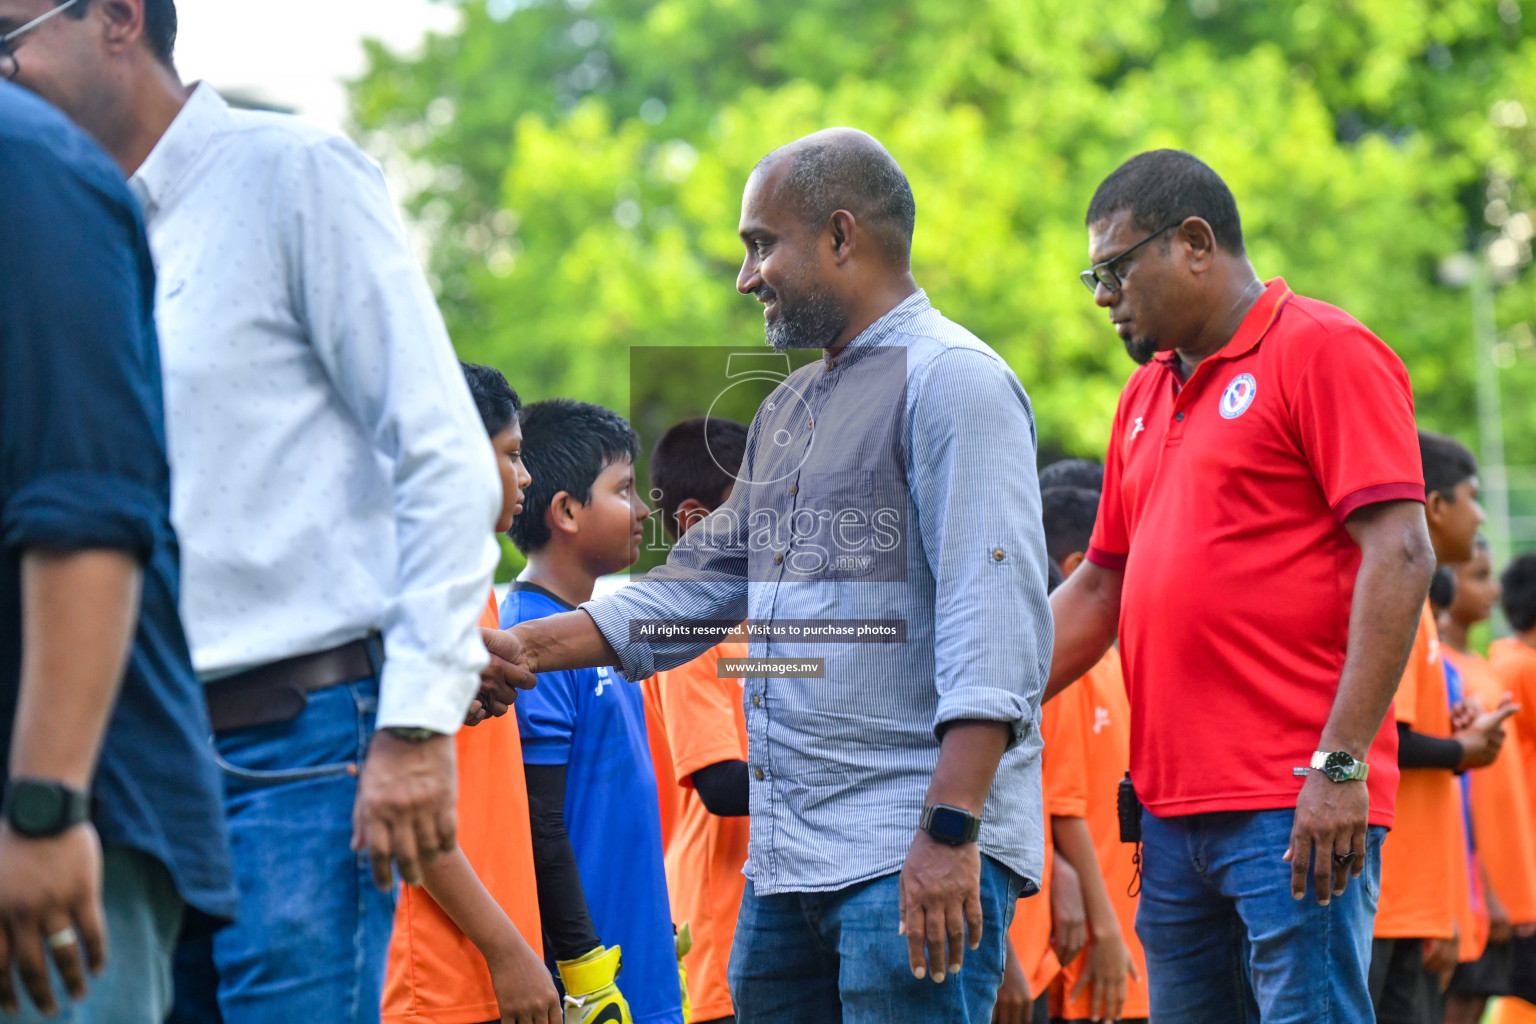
[1370, 430, 1513, 1024]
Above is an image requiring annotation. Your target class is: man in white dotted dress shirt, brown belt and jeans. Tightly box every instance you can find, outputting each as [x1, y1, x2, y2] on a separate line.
[0, 0, 501, 1024]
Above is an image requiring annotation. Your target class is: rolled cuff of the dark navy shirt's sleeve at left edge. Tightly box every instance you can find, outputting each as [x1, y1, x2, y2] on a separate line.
[0, 470, 162, 562]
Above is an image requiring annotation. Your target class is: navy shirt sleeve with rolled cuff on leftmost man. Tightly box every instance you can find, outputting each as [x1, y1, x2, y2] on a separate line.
[0, 137, 170, 562]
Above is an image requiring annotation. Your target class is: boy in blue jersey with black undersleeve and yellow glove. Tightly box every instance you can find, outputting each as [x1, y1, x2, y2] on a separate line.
[501, 399, 684, 1024]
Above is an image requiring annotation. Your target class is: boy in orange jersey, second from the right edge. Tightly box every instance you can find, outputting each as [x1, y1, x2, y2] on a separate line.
[1439, 536, 1536, 1024]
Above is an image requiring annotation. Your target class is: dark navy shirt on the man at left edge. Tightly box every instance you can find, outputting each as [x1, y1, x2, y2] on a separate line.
[0, 81, 235, 917]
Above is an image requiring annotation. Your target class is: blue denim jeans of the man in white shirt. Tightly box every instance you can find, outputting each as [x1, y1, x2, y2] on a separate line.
[169, 679, 395, 1024]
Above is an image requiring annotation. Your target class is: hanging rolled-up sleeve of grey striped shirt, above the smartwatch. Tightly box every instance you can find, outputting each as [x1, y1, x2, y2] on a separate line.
[908, 348, 1052, 742]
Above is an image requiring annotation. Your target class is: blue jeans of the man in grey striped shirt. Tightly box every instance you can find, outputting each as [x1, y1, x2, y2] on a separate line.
[727, 857, 1025, 1024]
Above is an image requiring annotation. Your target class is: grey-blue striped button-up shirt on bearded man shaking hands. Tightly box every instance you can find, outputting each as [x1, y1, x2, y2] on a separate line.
[582, 292, 1052, 895]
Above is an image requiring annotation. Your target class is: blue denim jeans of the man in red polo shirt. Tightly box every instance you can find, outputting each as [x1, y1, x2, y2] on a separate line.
[1137, 809, 1387, 1024]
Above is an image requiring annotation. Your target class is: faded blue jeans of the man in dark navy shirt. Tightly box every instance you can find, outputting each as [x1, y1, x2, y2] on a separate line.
[0, 846, 183, 1024]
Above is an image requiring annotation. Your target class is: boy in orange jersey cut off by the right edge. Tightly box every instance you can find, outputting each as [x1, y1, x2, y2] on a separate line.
[1488, 554, 1536, 1022]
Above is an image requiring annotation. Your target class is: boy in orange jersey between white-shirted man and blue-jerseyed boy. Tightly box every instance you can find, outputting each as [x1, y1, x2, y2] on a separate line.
[382, 364, 564, 1024]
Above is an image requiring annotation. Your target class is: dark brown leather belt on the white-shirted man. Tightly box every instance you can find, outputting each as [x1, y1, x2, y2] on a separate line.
[203, 633, 384, 732]
